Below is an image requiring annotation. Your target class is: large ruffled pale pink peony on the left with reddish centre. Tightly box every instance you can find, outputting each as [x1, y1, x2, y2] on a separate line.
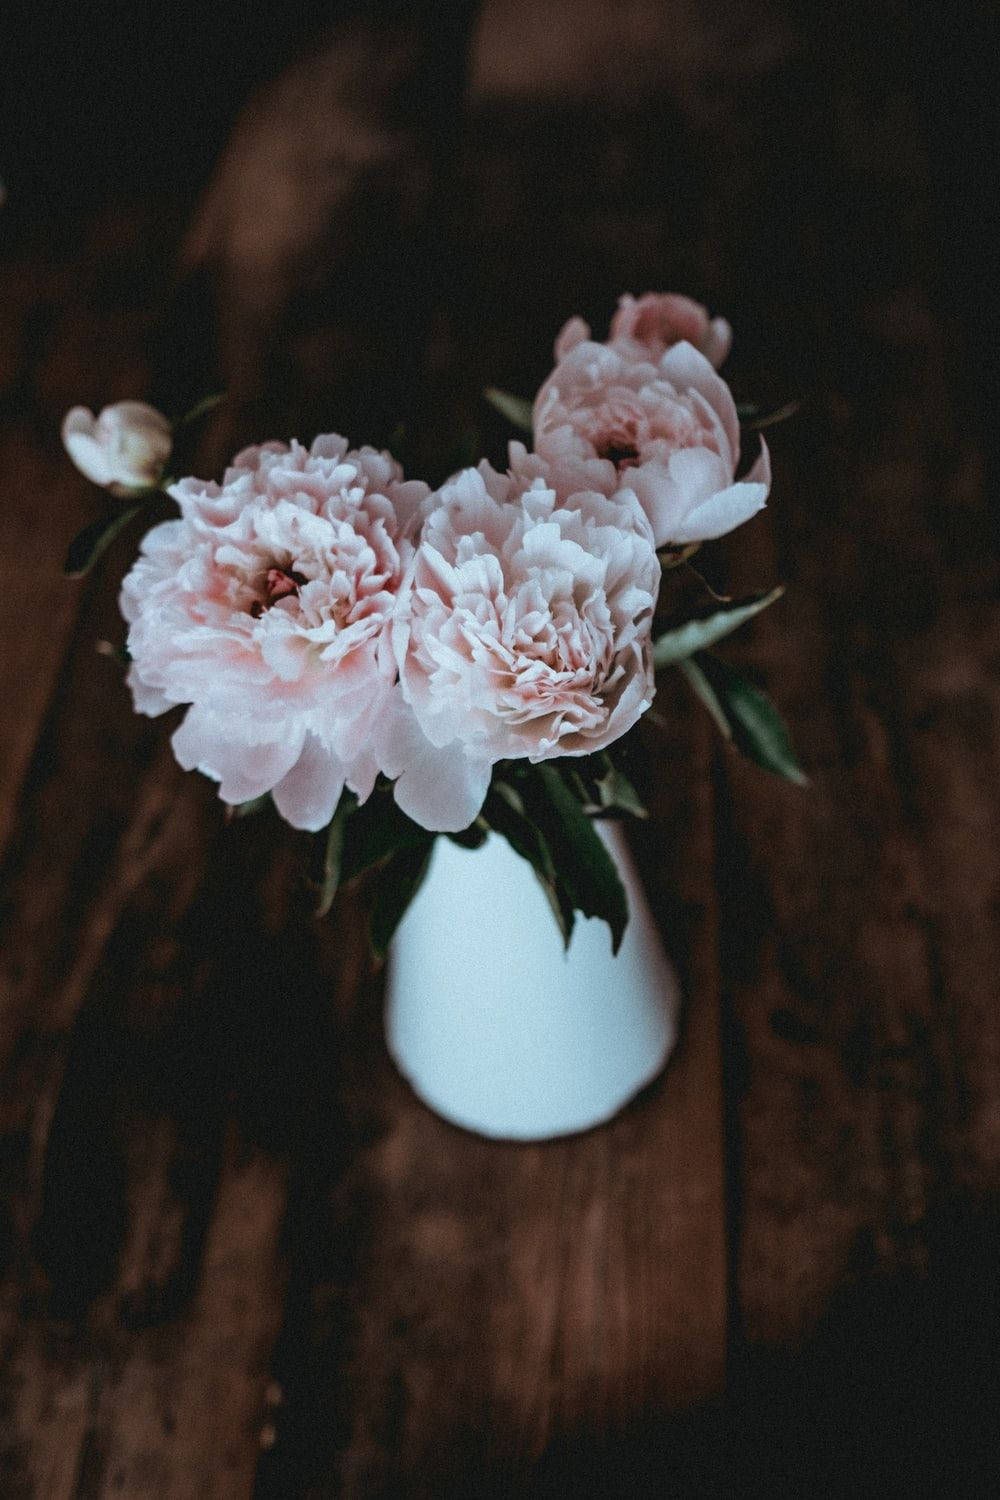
[121, 437, 429, 830]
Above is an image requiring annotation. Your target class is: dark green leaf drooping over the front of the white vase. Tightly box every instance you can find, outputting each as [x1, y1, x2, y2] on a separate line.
[522, 764, 628, 953]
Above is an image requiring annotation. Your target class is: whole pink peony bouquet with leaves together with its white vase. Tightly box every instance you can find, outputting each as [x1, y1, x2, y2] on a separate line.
[63, 294, 802, 1137]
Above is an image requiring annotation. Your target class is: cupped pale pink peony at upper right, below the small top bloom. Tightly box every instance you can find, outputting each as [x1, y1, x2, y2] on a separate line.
[534, 339, 771, 548]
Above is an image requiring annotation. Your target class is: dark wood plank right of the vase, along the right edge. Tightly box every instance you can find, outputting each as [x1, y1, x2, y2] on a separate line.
[692, 17, 1000, 1493]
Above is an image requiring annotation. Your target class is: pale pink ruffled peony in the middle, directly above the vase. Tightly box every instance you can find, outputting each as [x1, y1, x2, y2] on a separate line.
[381, 450, 660, 833]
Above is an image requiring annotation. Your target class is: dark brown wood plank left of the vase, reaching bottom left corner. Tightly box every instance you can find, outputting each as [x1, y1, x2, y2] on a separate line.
[3, 567, 296, 1497]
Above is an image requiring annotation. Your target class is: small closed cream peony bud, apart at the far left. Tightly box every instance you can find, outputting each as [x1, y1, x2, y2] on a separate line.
[63, 401, 172, 495]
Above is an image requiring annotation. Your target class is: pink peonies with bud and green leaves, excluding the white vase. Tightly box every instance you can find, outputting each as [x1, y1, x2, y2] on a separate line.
[66, 294, 802, 953]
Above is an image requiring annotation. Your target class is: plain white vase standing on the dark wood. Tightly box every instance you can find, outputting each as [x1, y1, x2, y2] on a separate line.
[385, 822, 679, 1140]
